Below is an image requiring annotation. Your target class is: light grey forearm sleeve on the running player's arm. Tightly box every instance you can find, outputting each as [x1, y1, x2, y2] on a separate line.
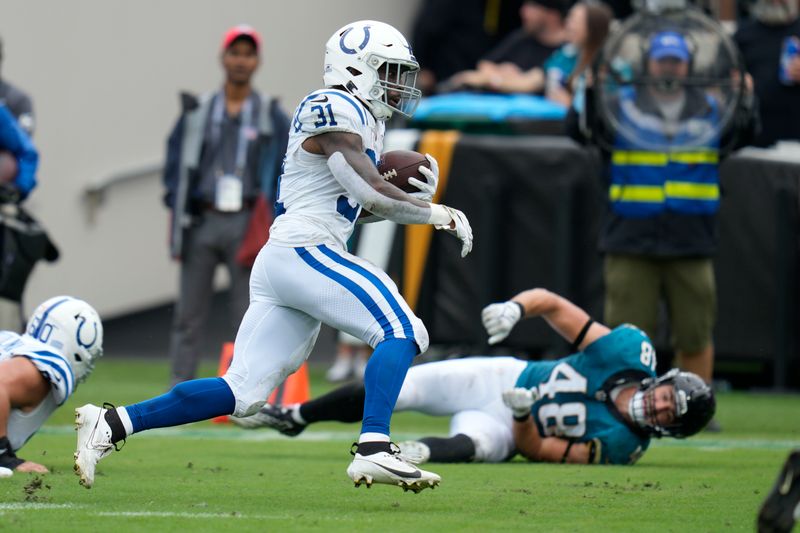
[328, 152, 450, 225]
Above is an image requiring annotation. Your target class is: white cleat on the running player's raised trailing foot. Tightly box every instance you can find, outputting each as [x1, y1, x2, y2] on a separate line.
[74, 404, 114, 489]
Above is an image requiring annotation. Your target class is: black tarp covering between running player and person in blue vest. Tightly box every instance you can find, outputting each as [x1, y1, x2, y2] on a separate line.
[418, 136, 604, 353]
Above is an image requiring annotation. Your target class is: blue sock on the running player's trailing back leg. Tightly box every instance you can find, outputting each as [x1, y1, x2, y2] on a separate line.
[125, 378, 236, 433]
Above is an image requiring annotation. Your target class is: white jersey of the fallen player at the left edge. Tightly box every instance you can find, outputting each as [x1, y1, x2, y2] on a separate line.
[0, 331, 75, 451]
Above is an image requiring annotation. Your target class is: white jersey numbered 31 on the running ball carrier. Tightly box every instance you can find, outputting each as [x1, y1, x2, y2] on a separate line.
[270, 88, 386, 249]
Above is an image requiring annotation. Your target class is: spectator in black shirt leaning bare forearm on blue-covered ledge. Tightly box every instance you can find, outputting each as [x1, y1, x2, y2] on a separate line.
[447, 0, 567, 93]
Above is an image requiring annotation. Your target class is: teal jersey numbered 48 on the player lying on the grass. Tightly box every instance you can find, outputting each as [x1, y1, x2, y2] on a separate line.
[516, 324, 656, 464]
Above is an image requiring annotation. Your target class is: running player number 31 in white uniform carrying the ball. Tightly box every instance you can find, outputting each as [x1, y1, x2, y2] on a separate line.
[75, 21, 472, 492]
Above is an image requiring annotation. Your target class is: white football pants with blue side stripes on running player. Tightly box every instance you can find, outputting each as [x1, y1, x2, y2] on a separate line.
[223, 243, 428, 417]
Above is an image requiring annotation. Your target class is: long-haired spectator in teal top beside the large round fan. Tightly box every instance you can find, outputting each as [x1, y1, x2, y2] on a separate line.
[544, 1, 613, 110]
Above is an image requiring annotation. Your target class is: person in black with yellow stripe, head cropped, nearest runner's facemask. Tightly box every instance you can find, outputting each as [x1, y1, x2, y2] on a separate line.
[411, 0, 522, 94]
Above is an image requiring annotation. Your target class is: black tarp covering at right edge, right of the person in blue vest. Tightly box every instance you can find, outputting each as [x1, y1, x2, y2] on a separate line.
[715, 156, 800, 386]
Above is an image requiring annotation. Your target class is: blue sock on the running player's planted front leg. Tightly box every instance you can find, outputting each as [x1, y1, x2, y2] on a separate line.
[361, 339, 419, 435]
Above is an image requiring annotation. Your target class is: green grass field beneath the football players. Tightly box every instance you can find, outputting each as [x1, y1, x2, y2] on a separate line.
[0, 358, 800, 533]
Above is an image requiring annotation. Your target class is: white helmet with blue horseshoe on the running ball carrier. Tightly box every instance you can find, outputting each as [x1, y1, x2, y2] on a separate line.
[322, 20, 422, 120]
